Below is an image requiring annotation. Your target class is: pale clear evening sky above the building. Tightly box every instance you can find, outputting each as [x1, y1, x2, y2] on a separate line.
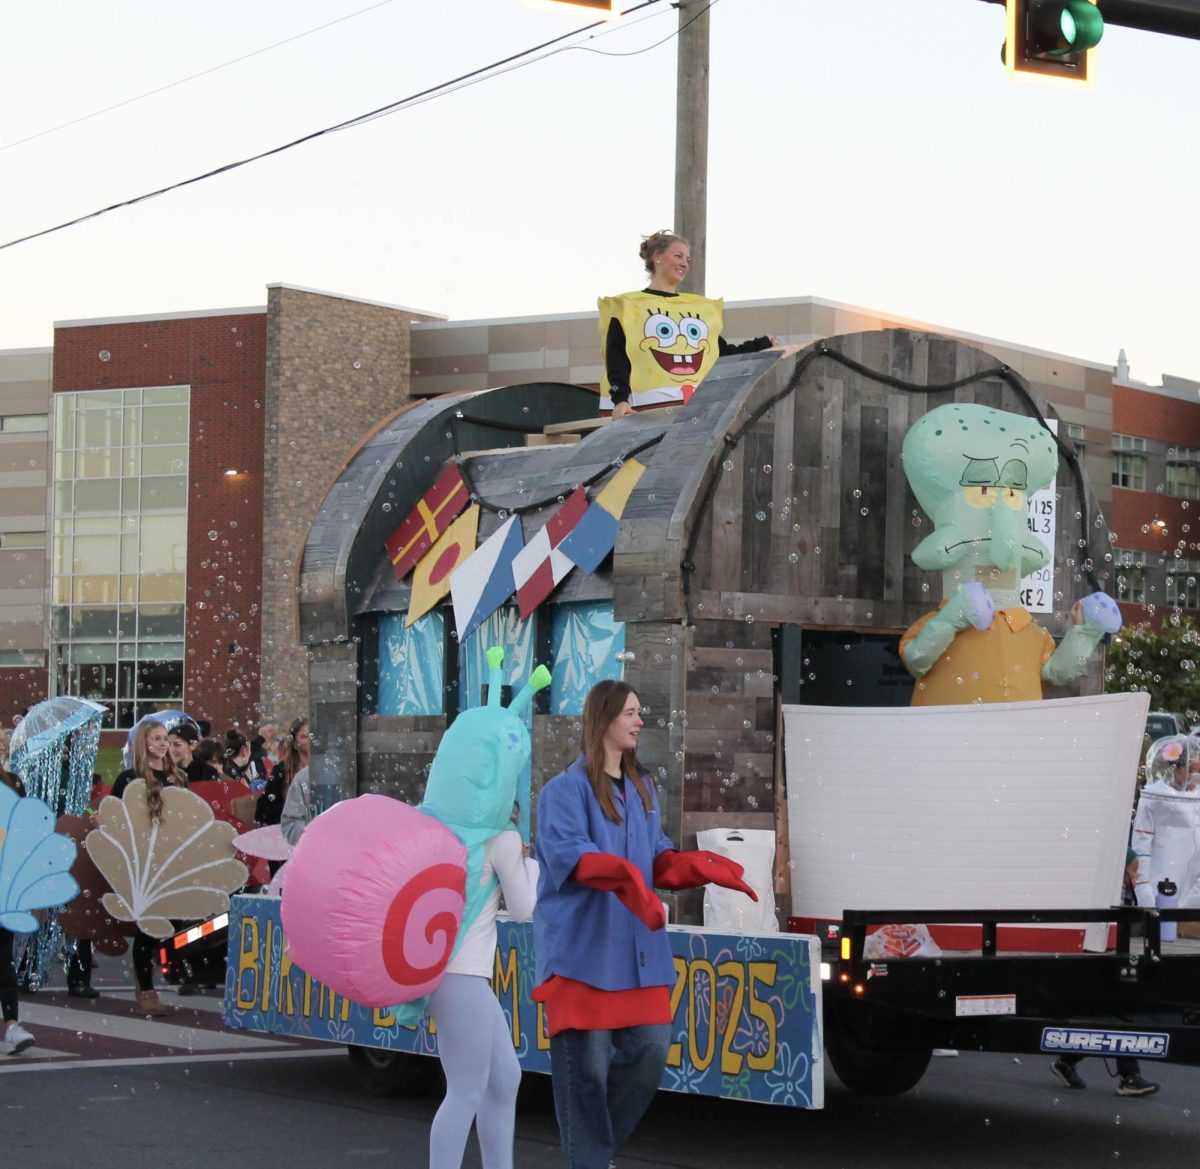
[0, 0, 1200, 384]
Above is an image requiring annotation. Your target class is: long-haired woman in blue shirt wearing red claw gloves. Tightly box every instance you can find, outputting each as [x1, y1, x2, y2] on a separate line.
[533, 679, 757, 1169]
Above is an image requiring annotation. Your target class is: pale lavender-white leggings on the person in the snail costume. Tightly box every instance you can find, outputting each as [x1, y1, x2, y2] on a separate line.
[430, 975, 521, 1169]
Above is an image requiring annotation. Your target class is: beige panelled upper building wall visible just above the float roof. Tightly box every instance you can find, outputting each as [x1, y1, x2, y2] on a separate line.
[413, 296, 1112, 508]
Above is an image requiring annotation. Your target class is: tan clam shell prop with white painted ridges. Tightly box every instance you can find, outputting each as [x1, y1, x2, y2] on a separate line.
[86, 779, 246, 937]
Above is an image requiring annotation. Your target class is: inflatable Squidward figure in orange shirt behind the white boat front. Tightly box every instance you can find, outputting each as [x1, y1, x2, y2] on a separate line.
[900, 402, 1121, 706]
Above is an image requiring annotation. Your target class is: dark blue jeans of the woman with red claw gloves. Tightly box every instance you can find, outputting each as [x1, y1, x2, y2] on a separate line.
[550, 1023, 671, 1169]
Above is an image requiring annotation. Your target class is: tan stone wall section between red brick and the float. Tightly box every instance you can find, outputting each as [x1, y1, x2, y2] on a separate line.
[260, 284, 446, 726]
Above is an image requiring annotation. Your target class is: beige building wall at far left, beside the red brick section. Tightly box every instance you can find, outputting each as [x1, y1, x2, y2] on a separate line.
[0, 349, 53, 670]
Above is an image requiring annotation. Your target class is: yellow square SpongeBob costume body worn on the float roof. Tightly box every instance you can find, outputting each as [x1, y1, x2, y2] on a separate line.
[598, 292, 725, 413]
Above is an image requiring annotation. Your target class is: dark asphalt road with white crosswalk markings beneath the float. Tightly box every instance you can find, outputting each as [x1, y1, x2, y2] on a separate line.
[0, 978, 1200, 1169]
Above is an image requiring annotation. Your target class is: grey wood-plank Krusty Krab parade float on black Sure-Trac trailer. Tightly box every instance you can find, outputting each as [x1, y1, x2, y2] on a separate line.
[226, 330, 1200, 1108]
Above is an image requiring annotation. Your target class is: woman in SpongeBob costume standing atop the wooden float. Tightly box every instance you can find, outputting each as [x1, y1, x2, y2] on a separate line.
[598, 229, 779, 418]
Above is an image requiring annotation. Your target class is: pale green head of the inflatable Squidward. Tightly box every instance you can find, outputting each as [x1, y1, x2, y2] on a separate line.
[902, 402, 1058, 595]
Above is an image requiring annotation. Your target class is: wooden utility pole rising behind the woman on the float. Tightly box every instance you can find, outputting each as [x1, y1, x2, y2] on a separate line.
[673, 0, 712, 295]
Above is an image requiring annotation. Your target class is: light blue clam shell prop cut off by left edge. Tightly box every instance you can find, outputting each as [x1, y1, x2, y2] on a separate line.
[0, 784, 79, 934]
